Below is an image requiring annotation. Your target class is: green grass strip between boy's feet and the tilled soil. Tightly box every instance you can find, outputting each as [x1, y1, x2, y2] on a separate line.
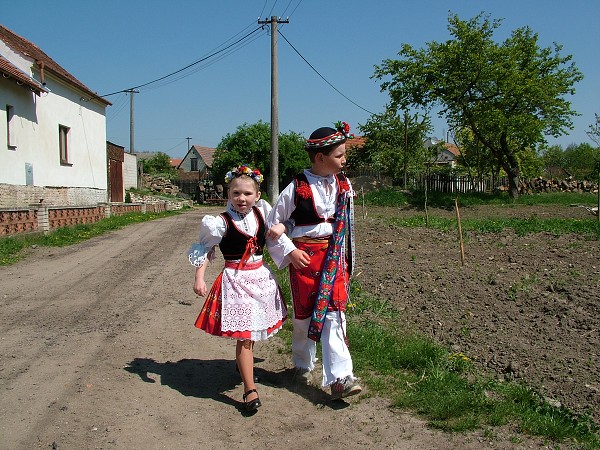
[338, 282, 600, 449]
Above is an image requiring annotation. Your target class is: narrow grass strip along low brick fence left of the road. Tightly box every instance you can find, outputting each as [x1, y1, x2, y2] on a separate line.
[0, 211, 179, 266]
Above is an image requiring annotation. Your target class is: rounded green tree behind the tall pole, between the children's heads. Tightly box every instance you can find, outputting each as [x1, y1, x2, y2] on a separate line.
[212, 121, 310, 197]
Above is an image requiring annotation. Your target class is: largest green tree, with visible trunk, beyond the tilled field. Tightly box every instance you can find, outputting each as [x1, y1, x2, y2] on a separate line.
[374, 14, 582, 197]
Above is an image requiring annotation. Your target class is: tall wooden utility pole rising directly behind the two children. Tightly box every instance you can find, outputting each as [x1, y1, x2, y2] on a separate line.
[258, 16, 290, 203]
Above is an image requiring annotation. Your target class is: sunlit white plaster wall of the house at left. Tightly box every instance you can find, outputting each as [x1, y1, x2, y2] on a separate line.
[0, 42, 108, 207]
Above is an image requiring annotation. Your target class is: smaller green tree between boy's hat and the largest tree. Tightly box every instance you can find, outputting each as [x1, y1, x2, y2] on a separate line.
[348, 107, 431, 187]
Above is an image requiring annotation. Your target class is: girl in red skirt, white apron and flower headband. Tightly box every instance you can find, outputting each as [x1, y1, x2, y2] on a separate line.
[188, 166, 287, 411]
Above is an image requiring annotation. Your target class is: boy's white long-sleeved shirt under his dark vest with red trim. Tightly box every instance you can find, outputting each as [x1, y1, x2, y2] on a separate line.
[267, 169, 353, 269]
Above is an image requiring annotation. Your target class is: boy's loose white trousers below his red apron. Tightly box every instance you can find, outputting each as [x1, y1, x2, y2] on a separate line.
[292, 311, 354, 387]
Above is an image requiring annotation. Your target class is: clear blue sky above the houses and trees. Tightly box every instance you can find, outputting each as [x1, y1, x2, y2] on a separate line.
[0, 0, 600, 157]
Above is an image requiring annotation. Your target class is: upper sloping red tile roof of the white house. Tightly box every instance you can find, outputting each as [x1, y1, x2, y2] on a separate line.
[0, 25, 111, 105]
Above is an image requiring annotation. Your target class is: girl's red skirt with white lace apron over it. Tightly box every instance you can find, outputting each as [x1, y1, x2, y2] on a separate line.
[194, 261, 287, 341]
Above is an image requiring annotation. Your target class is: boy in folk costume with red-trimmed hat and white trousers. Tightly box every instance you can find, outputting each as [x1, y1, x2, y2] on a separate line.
[267, 122, 362, 398]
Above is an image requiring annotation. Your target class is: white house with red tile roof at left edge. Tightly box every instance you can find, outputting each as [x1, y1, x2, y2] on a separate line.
[0, 25, 110, 208]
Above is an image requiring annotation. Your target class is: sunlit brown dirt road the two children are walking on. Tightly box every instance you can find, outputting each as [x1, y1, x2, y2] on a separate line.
[0, 209, 564, 449]
